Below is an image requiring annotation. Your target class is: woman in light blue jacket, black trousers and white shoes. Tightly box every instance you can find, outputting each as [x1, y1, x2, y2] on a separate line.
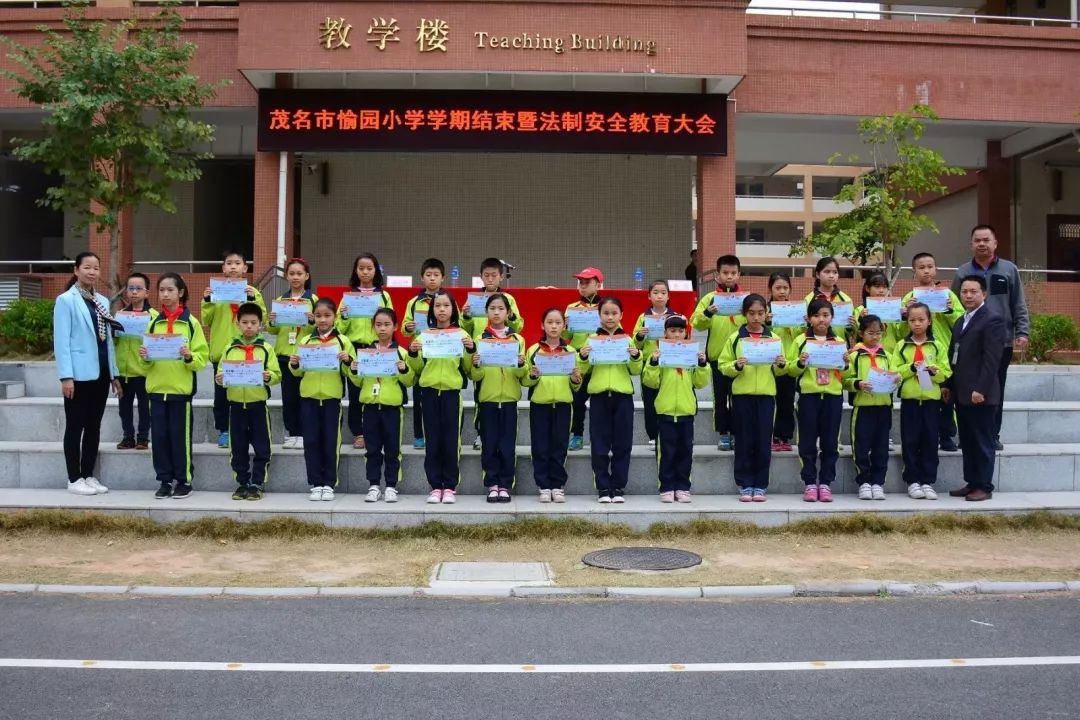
[53, 253, 121, 495]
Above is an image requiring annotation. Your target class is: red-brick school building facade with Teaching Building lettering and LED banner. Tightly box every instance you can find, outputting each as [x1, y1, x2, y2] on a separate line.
[0, 0, 1080, 309]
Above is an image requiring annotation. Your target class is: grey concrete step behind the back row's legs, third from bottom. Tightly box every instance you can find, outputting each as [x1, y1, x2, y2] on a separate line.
[0, 397, 1080, 445]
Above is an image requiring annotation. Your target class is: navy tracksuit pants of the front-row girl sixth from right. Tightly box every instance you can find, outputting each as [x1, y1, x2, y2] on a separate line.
[589, 392, 634, 498]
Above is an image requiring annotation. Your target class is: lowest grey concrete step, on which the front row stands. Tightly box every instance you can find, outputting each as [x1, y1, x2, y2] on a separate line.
[0, 490, 1080, 530]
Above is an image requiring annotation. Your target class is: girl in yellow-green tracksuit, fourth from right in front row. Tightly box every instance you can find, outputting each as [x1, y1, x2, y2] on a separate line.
[719, 293, 787, 502]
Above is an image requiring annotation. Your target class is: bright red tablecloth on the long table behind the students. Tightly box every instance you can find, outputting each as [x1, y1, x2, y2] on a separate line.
[315, 285, 698, 344]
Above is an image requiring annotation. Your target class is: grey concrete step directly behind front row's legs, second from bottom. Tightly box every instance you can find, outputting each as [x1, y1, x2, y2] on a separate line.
[0, 441, 1080, 494]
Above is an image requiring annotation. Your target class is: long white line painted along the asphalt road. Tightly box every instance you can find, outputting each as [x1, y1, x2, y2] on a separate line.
[0, 655, 1080, 675]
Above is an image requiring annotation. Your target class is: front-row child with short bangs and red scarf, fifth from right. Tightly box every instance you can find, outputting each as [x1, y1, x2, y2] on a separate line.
[642, 315, 710, 503]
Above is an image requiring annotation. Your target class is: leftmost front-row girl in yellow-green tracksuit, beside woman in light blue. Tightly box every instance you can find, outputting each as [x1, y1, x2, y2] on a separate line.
[138, 272, 210, 499]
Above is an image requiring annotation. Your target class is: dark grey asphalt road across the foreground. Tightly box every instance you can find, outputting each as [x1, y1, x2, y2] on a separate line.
[0, 595, 1080, 720]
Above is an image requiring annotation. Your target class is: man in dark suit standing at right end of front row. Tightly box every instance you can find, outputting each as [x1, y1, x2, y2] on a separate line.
[949, 275, 1009, 502]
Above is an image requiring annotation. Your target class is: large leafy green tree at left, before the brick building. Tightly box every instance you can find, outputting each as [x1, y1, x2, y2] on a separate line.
[0, 0, 216, 293]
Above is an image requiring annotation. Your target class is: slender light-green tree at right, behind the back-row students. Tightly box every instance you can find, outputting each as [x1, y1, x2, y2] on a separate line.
[789, 105, 964, 288]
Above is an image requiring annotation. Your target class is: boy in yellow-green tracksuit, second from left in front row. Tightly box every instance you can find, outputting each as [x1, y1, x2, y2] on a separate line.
[214, 302, 281, 500]
